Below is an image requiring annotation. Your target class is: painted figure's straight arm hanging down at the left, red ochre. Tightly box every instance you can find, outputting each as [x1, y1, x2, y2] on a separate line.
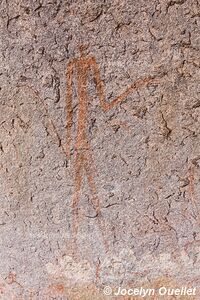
[66, 62, 74, 158]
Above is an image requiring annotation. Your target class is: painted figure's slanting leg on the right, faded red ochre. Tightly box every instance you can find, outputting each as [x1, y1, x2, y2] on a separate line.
[84, 149, 108, 251]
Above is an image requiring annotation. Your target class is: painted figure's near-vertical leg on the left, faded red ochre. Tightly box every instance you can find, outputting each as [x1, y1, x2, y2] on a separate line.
[72, 153, 84, 254]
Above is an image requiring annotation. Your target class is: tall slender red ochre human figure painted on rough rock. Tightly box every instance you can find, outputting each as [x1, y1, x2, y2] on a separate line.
[66, 45, 154, 253]
